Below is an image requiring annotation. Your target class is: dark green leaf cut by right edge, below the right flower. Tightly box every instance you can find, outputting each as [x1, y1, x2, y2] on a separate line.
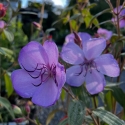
[111, 87, 125, 110]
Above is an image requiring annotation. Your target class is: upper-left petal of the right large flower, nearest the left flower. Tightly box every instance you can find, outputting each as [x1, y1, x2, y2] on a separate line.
[60, 42, 84, 64]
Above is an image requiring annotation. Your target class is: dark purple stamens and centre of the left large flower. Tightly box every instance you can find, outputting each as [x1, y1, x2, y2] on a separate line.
[22, 63, 58, 87]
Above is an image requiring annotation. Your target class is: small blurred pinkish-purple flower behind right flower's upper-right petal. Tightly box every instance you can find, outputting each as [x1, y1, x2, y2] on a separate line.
[97, 28, 112, 40]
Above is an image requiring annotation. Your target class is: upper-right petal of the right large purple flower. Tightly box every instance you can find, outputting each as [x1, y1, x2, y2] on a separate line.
[83, 38, 106, 60]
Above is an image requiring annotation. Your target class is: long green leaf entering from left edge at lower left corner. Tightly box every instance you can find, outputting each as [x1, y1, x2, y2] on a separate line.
[0, 97, 15, 119]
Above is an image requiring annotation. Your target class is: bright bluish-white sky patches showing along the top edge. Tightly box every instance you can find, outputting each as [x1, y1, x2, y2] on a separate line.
[22, 0, 66, 7]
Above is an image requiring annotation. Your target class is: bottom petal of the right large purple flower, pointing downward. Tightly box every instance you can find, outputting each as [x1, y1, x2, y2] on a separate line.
[85, 69, 106, 95]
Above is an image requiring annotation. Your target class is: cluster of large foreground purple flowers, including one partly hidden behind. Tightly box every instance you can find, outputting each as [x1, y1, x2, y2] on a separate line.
[11, 32, 120, 107]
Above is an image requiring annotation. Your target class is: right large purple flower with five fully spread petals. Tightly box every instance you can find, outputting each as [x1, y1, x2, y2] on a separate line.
[61, 33, 120, 94]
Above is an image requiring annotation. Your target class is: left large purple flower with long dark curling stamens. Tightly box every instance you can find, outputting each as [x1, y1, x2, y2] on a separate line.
[11, 41, 66, 107]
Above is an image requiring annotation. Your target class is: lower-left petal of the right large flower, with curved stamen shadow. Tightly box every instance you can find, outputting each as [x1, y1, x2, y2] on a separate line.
[66, 65, 86, 87]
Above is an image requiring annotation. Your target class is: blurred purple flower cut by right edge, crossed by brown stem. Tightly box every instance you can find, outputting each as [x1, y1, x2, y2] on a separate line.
[112, 6, 125, 28]
